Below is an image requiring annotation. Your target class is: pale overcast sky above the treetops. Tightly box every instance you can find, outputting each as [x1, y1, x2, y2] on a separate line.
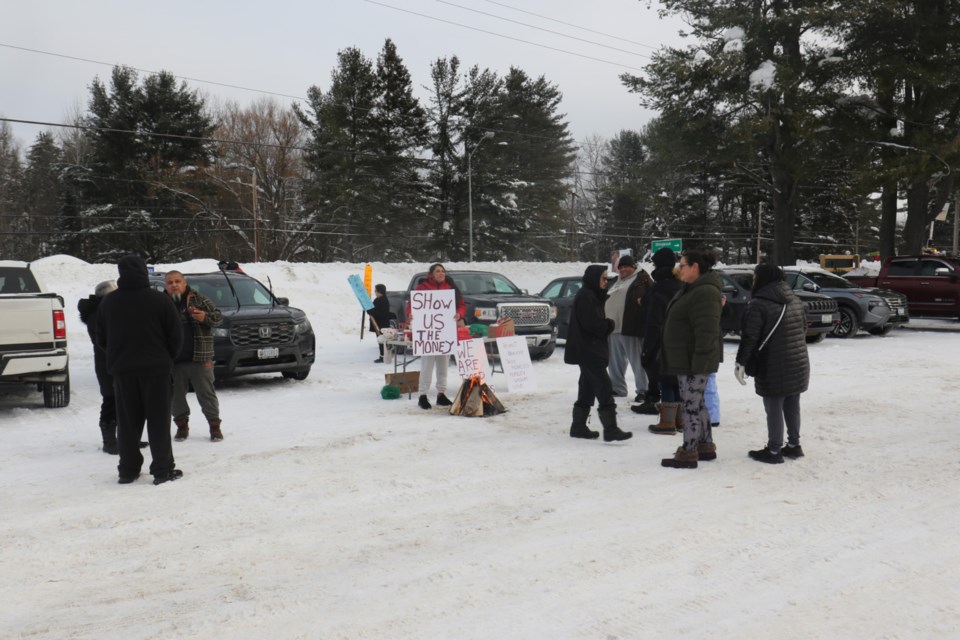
[0, 0, 684, 147]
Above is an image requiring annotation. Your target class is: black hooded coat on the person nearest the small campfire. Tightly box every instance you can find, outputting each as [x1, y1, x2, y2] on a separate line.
[563, 264, 614, 366]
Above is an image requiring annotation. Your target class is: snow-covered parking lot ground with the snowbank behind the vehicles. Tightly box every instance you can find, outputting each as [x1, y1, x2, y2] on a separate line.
[0, 257, 960, 640]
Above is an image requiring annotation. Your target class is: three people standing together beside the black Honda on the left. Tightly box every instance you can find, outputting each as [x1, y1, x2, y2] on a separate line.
[77, 255, 223, 484]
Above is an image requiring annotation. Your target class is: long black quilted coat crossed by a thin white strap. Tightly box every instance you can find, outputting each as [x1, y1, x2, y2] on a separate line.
[737, 282, 810, 397]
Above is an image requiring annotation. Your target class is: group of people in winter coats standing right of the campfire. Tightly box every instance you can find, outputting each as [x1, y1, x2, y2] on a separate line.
[564, 248, 810, 469]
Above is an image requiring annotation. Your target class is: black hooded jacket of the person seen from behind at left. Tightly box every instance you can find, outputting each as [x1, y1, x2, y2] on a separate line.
[96, 256, 183, 376]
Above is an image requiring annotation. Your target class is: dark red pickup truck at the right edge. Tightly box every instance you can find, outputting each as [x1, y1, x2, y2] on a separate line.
[846, 255, 960, 317]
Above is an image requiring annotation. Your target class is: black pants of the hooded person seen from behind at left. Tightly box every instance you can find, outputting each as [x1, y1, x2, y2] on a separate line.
[113, 371, 175, 477]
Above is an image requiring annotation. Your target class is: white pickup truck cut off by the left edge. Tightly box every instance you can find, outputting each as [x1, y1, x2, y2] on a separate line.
[0, 260, 70, 407]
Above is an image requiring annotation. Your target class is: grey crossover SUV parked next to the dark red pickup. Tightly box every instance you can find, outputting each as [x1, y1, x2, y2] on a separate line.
[784, 267, 910, 338]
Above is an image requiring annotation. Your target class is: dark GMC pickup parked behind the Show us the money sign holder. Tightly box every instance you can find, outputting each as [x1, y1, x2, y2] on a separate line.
[387, 271, 557, 360]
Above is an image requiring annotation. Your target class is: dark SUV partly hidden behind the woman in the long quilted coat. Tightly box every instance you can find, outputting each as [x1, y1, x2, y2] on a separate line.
[716, 267, 840, 342]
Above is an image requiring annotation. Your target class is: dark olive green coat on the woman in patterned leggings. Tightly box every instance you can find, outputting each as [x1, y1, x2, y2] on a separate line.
[660, 271, 723, 376]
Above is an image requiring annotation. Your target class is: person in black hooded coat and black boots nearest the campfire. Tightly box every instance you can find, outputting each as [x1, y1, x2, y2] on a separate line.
[563, 264, 633, 442]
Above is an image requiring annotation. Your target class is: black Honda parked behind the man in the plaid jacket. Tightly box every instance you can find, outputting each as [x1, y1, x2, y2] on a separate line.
[150, 270, 316, 380]
